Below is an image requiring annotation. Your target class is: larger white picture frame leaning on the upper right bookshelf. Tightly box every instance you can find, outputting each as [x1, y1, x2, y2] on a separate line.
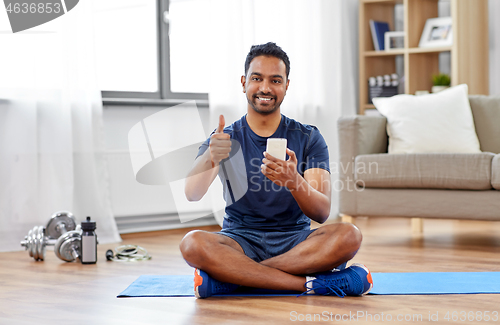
[418, 17, 453, 47]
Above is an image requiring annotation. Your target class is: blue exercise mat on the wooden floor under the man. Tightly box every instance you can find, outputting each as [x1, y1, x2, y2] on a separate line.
[118, 272, 500, 297]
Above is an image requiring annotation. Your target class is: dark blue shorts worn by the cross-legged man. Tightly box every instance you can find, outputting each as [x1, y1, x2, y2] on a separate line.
[217, 224, 316, 262]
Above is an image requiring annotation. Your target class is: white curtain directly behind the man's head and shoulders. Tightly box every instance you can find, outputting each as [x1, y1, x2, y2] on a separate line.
[208, 0, 358, 216]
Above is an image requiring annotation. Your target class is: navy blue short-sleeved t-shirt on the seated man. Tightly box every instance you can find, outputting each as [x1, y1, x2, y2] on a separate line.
[198, 115, 330, 231]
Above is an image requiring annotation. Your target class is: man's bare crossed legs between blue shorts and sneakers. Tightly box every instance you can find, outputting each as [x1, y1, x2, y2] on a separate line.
[180, 223, 362, 291]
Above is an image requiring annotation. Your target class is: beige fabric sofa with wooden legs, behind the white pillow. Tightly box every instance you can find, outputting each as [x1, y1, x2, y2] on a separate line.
[338, 96, 500, 232]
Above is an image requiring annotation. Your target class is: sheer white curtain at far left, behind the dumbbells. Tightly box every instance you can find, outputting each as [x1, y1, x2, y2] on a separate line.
[0, 1, 120, 252]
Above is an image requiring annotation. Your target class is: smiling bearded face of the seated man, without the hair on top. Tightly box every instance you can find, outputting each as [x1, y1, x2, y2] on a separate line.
[241, 55, 290, 115]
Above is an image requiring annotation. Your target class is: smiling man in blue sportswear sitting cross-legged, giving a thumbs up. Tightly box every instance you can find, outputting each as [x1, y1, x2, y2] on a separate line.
[180, 43, 372, 298]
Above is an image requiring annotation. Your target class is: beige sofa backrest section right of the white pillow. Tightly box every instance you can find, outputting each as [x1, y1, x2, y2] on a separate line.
[469, 95, 500, 153]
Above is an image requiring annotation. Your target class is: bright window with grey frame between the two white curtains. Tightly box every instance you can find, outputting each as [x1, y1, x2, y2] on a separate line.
[93, 0, 209, 102]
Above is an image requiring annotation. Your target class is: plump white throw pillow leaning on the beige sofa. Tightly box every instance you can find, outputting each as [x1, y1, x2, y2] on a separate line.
[373, 84, 481, 154]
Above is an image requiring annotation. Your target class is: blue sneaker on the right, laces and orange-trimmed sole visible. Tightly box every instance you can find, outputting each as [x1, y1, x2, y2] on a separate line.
[304, 263, 373, 297]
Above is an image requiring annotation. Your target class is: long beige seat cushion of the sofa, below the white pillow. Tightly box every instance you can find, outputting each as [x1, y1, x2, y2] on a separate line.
[354, 152, 495, 190]
